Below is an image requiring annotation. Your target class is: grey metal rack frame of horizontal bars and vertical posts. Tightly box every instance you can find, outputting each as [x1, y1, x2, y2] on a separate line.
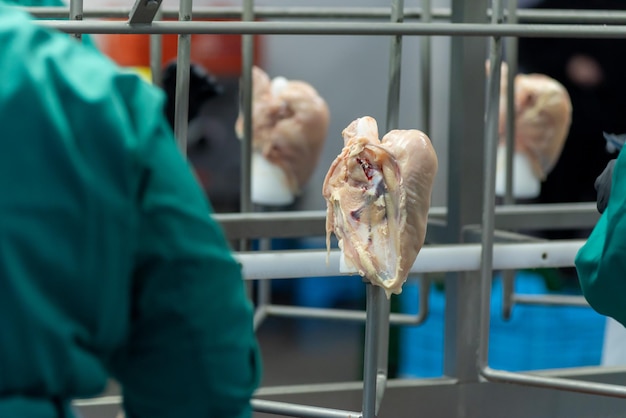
[28, 0, 626, 418]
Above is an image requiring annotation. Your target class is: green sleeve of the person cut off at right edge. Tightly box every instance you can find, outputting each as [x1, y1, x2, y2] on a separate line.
[576, 153, 626, 325]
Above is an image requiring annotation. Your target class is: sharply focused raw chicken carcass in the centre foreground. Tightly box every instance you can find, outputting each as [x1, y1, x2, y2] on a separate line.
[322, 116, 438, 297]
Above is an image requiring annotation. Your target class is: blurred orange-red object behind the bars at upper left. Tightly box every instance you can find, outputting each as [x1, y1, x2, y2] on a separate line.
[96, 18, 261, 76]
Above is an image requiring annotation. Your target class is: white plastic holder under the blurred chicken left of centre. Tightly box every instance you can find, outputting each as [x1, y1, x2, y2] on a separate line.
[250, 152, 295, 206]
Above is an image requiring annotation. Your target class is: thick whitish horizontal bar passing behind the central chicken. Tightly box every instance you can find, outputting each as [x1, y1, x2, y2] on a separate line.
[235, 240, 585, 280]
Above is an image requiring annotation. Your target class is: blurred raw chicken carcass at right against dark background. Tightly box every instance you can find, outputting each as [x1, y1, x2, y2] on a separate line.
[492, 63, 572, 197]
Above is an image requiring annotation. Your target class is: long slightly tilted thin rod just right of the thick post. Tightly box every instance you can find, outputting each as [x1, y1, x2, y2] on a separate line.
[478, 0, 503, 369]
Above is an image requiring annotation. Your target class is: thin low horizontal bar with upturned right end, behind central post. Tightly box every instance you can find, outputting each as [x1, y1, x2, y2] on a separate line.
[265, 304, 428, 325]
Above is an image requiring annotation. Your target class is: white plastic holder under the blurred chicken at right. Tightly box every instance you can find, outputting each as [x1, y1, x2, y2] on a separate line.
[496, 144, 541, 199]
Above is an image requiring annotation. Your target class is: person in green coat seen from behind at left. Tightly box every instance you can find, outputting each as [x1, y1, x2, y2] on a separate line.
[0, 0, 261, 418]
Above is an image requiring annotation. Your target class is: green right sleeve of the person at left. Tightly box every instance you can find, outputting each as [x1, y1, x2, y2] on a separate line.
[108, 108, 260, 418]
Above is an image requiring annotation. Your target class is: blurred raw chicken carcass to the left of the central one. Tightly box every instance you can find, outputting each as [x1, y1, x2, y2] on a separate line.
[235, 66, 329, 203]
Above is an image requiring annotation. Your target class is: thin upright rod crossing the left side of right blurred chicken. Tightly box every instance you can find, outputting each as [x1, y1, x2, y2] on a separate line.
[502, 0, 517, 319]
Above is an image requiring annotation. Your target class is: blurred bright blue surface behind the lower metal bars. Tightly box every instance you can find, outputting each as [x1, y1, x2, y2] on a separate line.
[399, 273, 605, 377]
